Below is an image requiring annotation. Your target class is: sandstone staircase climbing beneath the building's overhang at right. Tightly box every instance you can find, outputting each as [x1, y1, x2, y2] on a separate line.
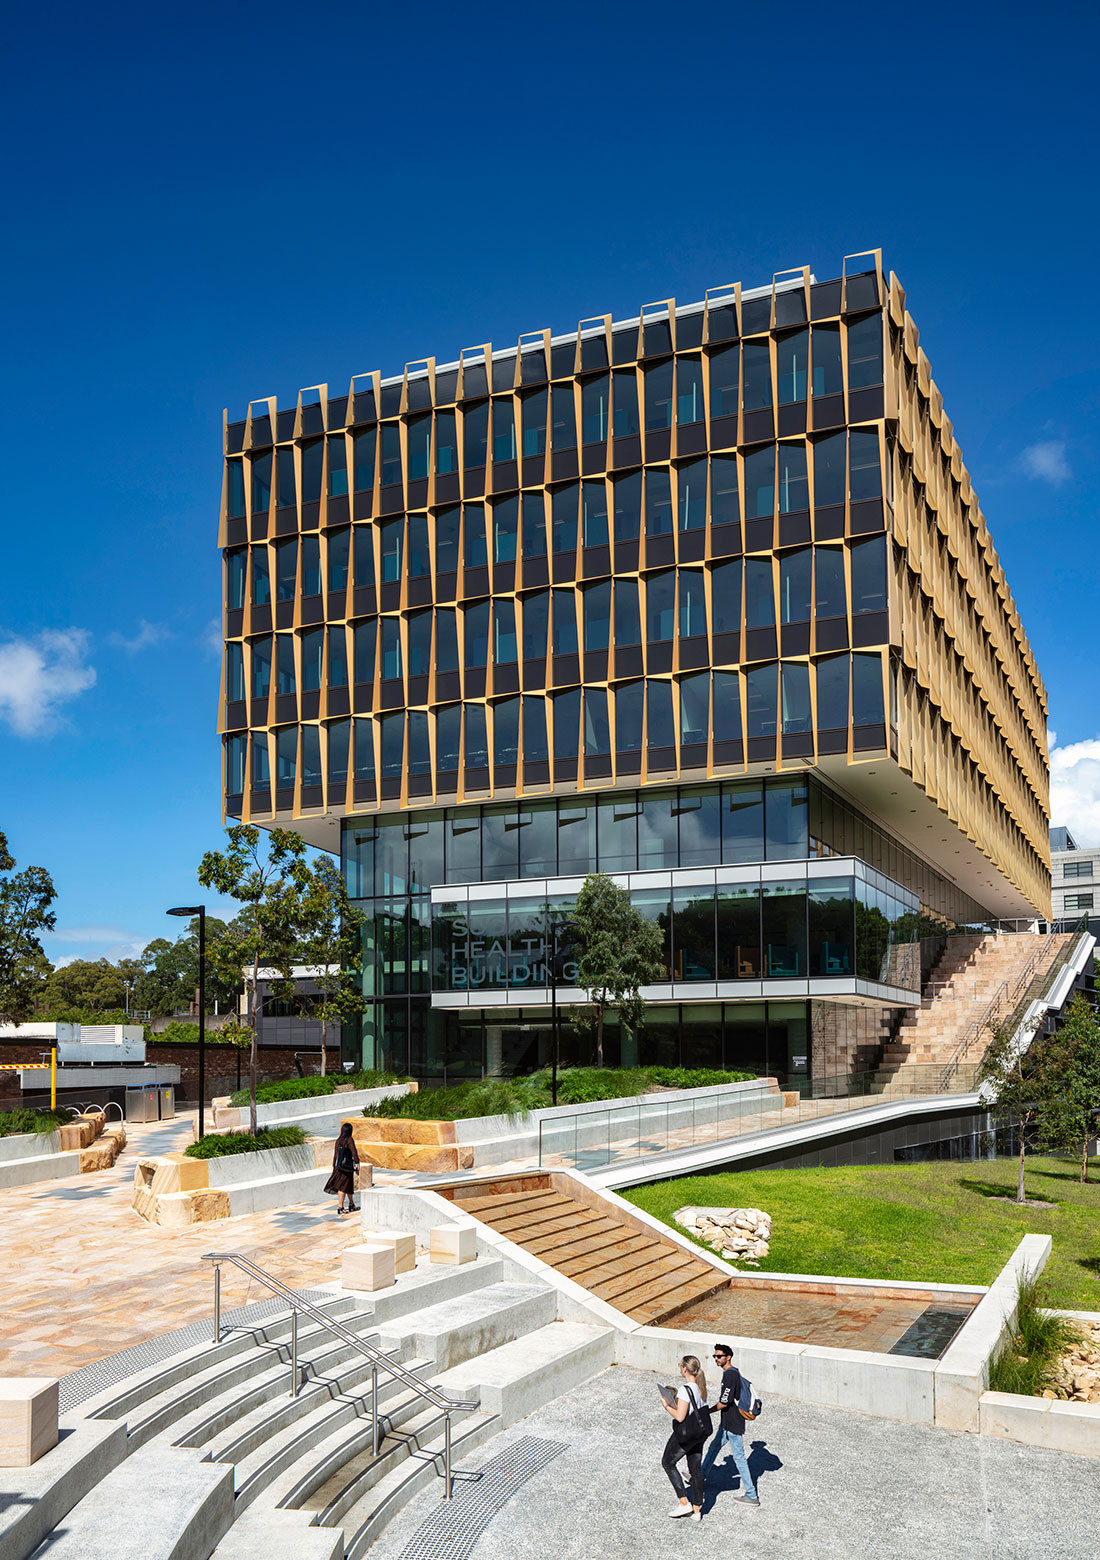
[875, 931, 1072, 1095]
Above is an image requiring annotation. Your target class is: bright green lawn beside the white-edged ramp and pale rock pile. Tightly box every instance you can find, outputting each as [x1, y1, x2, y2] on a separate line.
[623, 1159, 1100, 1310]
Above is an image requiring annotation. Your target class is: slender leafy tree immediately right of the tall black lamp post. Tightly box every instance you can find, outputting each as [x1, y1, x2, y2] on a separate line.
[198, 824, 310, 1136]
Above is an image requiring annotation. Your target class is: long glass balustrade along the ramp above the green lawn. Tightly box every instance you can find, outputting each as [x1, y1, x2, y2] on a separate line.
[538, 1062, 977, 1168]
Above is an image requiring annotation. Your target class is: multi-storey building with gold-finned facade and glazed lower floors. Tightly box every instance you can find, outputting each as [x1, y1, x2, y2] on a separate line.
[220, 253, 1050, 1080]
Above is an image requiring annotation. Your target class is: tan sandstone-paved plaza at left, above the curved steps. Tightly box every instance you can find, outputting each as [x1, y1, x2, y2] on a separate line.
[0, 1115, 360, 1376]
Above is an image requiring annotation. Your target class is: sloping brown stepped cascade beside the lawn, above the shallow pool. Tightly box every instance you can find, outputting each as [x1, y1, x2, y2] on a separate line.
[454, 1178, 729, 1323]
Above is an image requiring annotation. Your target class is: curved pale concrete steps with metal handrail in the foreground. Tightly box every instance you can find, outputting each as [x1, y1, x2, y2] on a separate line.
[10, 1256, 613, 1560]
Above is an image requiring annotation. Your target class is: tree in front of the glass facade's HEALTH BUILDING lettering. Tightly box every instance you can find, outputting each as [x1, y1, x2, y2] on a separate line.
[570, 872, 665, 1067]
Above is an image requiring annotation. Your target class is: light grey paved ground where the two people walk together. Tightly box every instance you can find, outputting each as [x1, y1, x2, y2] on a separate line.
[370, 1359, 1100, 1560]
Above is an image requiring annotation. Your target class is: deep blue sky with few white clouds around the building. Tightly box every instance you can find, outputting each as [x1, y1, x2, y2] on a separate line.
[0, 3, 1100, 959]
